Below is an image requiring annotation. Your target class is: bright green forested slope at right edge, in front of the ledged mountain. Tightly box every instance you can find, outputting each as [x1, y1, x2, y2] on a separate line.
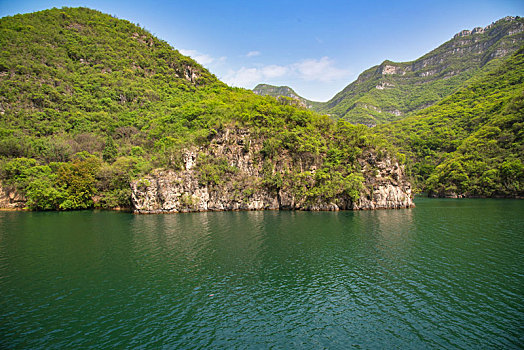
[377, 46, 524, 197]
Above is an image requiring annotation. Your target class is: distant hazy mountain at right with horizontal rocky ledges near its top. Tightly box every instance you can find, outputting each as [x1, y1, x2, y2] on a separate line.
[315, 17, 524, 125]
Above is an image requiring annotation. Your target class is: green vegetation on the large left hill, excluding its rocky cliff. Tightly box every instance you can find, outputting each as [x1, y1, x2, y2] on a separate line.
[0, 8, 392, 210]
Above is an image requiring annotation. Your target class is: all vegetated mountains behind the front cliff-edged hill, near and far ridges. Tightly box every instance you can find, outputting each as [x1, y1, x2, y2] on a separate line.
[253, 17, 524, 197]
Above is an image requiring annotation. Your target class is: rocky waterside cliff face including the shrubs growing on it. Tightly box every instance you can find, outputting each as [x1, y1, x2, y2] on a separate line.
[131, 129, 413, 213]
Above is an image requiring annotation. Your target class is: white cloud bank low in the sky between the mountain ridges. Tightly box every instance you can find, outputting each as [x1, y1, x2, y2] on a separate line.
[223, 56, 350, 87]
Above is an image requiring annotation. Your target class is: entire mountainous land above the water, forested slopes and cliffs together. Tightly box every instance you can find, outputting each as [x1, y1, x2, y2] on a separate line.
[0, 8, 524, 213]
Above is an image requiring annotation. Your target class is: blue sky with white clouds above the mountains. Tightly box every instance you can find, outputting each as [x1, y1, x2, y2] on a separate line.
[0, 0, 524, 101]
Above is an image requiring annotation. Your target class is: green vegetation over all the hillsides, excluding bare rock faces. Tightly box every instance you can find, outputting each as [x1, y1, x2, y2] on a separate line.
[0, 8, 524, 210]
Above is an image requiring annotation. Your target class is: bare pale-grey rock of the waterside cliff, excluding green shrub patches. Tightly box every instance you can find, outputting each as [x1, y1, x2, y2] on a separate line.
[131, 129, 414, 213]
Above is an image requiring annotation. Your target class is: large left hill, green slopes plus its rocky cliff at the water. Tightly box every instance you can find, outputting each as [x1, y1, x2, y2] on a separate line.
[0, 8, 412, 212]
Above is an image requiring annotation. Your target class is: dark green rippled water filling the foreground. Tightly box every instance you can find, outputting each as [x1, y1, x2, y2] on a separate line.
[0, 198, 524, 349]
